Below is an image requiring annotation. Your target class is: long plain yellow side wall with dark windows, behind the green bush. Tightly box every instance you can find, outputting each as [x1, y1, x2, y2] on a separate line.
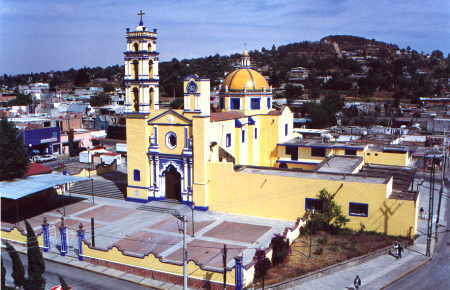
[208, 162, 415, 236]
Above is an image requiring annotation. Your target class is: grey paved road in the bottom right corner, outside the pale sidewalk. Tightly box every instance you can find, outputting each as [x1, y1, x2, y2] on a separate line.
[386, 181, 450, 290]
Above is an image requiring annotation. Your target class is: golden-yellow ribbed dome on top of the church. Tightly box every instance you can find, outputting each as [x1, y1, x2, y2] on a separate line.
[223, 68, 269, 91]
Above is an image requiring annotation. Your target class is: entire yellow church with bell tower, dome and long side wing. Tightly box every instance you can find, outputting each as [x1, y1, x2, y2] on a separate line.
[124, 17, 417, 236]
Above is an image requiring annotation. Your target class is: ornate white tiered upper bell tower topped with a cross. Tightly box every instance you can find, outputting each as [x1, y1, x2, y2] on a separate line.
[124, 10, 159, 113]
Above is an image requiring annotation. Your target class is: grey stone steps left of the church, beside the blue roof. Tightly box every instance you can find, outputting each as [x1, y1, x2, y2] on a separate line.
[69, 179, 124, 199]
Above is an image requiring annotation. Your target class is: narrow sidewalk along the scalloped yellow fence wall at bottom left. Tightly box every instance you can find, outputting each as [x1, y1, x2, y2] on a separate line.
[2, 243, 183, 289]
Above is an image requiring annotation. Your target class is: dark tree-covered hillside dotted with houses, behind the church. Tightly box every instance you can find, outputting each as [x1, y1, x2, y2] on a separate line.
[0, 35, 450, 100]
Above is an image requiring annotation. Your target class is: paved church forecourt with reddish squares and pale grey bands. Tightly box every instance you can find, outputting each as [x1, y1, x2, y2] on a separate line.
[2, 196, 294, 270]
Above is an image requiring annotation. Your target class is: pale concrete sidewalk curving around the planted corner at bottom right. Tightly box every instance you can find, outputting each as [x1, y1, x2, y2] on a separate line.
[271, 177, 449, 290]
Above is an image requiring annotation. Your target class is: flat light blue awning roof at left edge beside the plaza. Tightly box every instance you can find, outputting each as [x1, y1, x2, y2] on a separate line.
[0, 173, 89, 199]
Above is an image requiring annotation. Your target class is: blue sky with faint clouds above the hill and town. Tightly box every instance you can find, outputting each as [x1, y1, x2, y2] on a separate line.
[0, 0, 450, 74]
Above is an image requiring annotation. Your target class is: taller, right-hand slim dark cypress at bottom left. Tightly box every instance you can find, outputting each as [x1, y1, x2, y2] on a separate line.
[25, 220, 45, 289]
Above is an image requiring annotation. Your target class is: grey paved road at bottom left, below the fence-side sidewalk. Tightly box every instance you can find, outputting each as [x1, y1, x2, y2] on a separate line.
[2, 249, 151, 290]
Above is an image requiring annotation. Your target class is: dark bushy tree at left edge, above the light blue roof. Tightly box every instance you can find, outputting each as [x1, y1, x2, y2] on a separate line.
[0, 118, 30, 181]
